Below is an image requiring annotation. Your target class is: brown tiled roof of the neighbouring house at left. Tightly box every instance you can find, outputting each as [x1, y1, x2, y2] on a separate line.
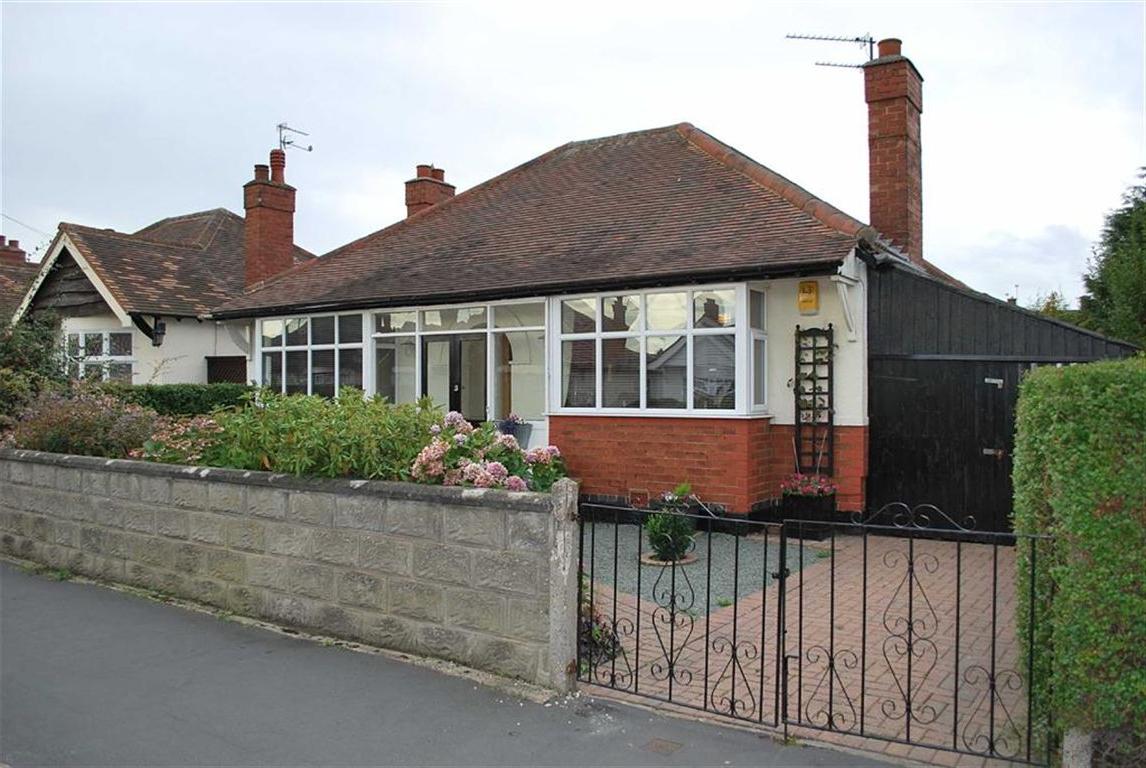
[60, 209, 314, 316]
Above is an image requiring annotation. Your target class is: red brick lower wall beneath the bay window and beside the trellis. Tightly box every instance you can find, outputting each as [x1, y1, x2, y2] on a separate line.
[549, 416, 868, 515]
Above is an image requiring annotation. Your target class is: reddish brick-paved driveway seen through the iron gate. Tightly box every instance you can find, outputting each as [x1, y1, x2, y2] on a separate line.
[582, 535, 1039, 766]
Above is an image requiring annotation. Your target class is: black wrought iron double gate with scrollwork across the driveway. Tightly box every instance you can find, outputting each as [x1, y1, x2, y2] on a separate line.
[578, 504, 1052, 765]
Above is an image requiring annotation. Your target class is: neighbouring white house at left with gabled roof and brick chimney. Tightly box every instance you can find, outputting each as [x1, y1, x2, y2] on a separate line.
[11, 149, 314, 384]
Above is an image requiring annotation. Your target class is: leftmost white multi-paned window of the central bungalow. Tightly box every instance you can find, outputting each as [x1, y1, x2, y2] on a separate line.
[260, 314, 363, 398]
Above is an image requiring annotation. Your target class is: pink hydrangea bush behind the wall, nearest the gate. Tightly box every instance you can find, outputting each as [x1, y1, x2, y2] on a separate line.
[410, 410, 565, 491]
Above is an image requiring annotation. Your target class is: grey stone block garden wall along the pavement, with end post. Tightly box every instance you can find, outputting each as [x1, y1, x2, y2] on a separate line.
[0, 449, 578, 690]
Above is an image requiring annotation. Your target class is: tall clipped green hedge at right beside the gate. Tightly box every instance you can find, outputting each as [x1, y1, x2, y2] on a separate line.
[1014, 356, 1146, 747]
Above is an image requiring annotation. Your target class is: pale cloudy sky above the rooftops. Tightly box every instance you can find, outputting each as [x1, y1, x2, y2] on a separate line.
[0, 0, 1146, 304]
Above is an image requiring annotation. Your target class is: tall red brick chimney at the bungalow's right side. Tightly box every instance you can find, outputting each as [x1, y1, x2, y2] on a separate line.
[863, 38, 924, 261]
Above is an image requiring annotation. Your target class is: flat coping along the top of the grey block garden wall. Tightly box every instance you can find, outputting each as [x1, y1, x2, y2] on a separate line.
[0, 448, 554, 512]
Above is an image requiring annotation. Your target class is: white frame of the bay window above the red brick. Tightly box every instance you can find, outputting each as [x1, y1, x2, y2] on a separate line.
[549, 283, 751, 418]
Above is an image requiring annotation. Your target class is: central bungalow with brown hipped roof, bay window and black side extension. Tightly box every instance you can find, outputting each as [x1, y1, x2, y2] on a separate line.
[212, 39, 1132, 530]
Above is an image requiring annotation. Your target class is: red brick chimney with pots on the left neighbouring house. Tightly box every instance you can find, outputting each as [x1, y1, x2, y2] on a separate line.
[243, 149, 295, 285]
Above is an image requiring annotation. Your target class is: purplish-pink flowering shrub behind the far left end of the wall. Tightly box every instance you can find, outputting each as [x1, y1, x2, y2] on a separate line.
[10, 386, 159, 459]
